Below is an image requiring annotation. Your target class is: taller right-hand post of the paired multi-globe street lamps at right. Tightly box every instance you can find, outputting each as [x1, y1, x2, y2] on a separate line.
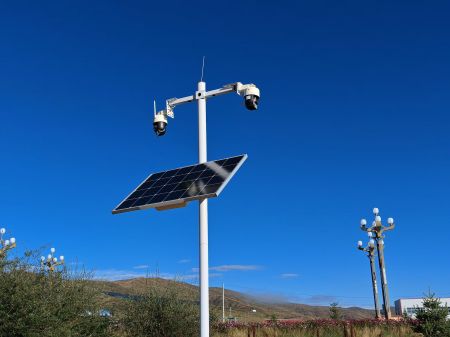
[361, 208, 395, 319]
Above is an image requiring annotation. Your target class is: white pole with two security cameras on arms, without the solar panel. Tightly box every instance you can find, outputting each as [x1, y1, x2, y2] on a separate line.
[153, 79, 260, 337]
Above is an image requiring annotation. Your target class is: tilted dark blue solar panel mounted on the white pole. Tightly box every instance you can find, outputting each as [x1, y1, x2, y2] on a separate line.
[112, 154, 247, 214]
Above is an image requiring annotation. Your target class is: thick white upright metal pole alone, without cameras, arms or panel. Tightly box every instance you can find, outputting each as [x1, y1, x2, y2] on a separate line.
[196, 81, 209, 337]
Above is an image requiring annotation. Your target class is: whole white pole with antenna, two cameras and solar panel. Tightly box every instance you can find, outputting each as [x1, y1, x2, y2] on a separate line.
[112, 54, 260, 337]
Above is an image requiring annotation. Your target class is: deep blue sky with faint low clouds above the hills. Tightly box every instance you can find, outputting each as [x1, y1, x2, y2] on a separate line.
[0, 1, 450, 306]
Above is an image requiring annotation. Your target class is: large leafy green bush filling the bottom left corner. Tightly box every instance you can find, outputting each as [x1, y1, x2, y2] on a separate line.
[0, 254, 109, 337]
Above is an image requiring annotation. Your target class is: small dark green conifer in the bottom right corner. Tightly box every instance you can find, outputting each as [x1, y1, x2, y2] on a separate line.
[416, 291, 450, 337]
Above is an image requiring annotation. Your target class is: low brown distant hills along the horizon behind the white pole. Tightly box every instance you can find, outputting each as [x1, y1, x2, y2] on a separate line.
[94, 278, 374, 321]
